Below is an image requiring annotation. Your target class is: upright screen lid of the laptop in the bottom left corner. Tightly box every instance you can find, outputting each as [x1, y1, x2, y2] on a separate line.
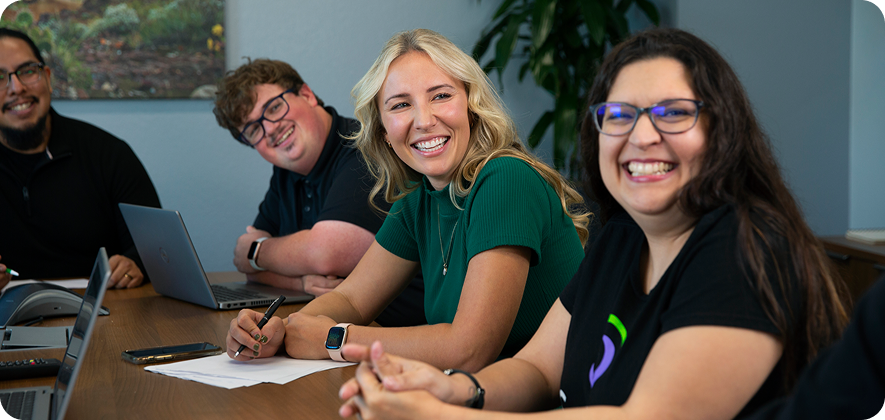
[51, 248, 111, 419]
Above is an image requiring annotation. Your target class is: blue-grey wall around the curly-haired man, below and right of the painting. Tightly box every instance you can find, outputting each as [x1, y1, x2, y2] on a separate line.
[53, 0, 552, 271]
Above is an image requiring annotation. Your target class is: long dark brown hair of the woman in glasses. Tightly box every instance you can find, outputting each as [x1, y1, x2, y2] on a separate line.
[581, 28, 848, 387]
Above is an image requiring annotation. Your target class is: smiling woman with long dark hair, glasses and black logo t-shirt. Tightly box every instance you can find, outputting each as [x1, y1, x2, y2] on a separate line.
[341, 29, 847, 419]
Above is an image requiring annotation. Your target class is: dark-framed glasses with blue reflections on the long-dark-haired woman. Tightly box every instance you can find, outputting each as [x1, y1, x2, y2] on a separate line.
[590, 99, 704, 136]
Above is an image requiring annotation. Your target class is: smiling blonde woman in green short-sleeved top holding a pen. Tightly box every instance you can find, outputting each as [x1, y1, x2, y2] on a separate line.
[227, 29, 588, 371]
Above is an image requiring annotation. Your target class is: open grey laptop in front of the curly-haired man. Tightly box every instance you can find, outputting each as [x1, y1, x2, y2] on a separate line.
[120, 203, 313, 310]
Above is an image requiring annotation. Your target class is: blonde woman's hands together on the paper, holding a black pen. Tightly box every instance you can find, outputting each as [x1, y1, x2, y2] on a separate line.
[225, 309, 336, 361]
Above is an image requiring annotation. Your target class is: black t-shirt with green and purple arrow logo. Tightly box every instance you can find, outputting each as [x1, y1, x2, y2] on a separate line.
[560, 205, 796, 416]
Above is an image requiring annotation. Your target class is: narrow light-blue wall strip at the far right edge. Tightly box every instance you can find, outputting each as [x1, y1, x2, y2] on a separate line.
[849, 0, 885, 229]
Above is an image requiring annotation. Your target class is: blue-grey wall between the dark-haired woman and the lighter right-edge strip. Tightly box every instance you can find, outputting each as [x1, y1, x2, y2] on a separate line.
[675, 0, 852, 235]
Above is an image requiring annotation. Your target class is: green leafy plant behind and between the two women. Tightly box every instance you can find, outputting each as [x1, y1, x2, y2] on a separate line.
[473, 0, 660, 180]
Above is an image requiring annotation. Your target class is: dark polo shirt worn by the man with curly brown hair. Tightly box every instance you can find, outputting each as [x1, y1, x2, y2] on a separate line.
[253, 107, 427, 327]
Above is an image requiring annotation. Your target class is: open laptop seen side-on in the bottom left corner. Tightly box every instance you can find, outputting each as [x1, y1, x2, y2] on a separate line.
[0, 248, 111, 420]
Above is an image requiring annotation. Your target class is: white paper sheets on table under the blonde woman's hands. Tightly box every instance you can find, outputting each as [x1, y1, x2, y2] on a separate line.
[144, 354, 354, 389]
